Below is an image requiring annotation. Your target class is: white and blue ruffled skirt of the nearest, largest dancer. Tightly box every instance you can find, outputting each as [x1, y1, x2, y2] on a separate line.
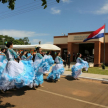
[0, 61, 35, 91]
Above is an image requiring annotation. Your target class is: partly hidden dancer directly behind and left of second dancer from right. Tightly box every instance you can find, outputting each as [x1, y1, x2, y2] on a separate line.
[43, 51, 54, 75]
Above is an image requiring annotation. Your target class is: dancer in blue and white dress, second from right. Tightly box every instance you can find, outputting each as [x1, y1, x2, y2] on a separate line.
[47, 52, 64, 81]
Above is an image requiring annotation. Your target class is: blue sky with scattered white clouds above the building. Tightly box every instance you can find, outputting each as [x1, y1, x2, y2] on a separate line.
[0, 0, 108, 44]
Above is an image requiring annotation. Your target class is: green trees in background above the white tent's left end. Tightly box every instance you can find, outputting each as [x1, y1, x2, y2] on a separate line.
[0, 35, 30, 45]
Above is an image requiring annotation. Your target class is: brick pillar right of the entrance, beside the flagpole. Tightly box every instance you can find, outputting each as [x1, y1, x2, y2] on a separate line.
[94, 42, 101, 66]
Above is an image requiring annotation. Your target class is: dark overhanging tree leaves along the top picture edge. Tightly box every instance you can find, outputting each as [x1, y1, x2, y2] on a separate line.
[0, 0, 60, 10]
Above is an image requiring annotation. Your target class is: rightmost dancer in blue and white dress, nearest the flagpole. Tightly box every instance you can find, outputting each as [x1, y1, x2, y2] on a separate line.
[72, 53, 89, 80]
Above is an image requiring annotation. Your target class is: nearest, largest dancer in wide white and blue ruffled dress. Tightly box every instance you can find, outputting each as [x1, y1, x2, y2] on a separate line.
[0, 42, 34, 91]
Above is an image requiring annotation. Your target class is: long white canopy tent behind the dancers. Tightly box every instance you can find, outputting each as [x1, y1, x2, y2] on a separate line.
[13, 44, 61, 51]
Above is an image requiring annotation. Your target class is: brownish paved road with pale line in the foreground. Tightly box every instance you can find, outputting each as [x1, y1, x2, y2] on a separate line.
[0, 76, 108, 108]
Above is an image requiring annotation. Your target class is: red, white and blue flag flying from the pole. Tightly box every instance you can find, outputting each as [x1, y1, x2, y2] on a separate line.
[83, 25, 105, 42]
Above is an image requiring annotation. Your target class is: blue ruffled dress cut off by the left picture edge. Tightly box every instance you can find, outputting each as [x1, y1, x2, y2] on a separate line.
[0, 53, 7, 76]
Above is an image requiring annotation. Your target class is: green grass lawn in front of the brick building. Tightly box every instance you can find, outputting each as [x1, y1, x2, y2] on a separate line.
[67, 67, 108, 75]
